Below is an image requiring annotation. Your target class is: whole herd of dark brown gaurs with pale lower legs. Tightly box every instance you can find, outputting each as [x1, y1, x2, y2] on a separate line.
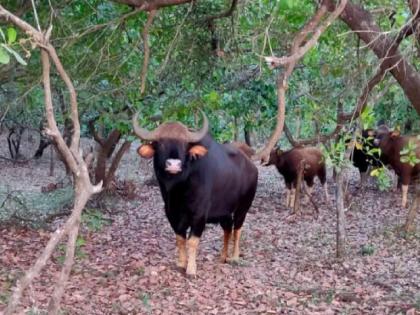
[133, 113, 420, 275]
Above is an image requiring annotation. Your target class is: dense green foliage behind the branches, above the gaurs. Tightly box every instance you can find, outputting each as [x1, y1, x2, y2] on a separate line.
[0, 0, 420, 146]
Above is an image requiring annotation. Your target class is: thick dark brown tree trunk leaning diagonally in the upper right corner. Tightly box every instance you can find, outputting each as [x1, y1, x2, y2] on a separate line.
[323, 0, 420, 114]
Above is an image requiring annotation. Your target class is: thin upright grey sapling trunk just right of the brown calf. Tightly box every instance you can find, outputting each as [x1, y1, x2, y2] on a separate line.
[335, 170, 346, 258]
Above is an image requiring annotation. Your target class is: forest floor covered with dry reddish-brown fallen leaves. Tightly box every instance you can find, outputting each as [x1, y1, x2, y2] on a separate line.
[0, 137, 420, 315]
